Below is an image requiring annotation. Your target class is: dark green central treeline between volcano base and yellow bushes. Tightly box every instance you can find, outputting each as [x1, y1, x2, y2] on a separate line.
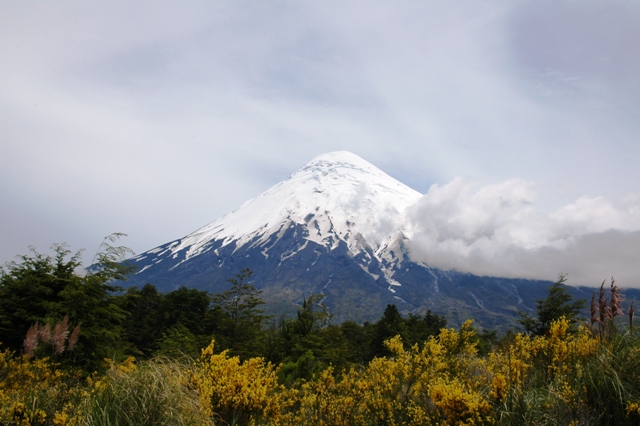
[116, 270, 460, 380]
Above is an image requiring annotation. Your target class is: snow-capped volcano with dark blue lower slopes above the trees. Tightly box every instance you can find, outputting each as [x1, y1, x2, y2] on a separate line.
[126, 151, 576, 327]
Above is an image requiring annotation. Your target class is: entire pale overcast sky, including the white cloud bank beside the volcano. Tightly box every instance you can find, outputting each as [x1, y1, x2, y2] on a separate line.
[0, 0, 640, 287]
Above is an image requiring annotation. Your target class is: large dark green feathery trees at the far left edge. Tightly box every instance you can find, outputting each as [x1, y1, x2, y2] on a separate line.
[0, 234, 132, 371]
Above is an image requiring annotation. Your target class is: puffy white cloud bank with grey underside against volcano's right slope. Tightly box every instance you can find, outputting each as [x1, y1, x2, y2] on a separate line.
[407, 178, 640, 287]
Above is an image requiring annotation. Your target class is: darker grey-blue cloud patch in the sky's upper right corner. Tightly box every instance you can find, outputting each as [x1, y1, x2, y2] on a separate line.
[510, 0, 640, 100]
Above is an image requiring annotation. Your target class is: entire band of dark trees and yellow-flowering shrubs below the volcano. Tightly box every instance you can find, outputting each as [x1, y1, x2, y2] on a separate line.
[0, 238, 640, 425]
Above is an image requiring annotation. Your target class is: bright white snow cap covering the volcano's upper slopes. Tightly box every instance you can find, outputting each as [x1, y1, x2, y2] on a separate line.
[154, 151, 421, 260]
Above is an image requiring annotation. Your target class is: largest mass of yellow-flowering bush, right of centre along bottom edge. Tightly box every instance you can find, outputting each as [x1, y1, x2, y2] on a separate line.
[291, 322, 492, 425]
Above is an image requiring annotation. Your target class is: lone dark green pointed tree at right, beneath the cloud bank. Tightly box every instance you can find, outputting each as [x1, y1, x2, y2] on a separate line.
[518, 274, 585, 336]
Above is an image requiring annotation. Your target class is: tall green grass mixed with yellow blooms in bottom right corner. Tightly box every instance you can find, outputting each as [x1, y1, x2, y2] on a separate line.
[496, 324, 640, 426]
